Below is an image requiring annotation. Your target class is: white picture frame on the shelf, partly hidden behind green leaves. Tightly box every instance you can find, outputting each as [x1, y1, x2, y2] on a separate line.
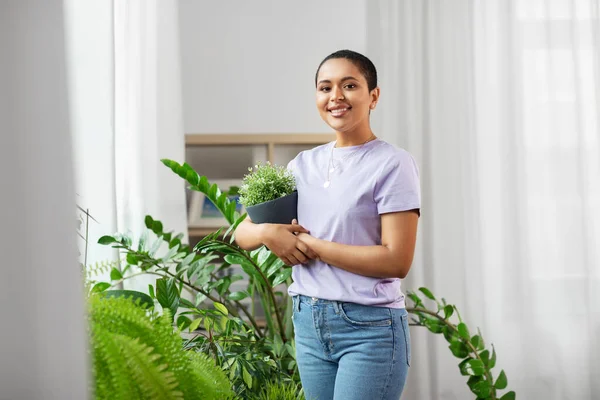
[188, 179, 246, 229]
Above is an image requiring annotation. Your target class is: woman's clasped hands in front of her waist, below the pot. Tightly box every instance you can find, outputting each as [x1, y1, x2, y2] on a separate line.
[263, 220, 317, 266]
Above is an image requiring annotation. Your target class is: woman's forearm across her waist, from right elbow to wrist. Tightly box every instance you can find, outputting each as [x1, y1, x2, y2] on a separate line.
[298, 234, 413, 278]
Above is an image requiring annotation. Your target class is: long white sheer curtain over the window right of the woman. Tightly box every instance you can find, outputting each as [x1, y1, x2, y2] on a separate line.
[367, 0, 600, 400]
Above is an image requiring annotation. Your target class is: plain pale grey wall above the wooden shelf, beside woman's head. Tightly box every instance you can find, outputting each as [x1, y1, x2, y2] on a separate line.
[179, 0, 366, 133]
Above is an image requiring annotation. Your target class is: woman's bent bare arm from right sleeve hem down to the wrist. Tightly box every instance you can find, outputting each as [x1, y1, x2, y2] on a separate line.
[298, 211, 419, 278]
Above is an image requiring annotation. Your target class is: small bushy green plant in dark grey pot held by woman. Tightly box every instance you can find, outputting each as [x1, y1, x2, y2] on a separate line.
[239, 162, 298, 224]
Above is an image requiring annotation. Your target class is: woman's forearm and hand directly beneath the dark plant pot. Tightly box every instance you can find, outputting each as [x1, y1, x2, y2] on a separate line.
[235, 217, 317, 266]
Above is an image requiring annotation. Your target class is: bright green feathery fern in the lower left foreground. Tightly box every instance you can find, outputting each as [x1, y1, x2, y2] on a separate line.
[88, 294, 233, 400]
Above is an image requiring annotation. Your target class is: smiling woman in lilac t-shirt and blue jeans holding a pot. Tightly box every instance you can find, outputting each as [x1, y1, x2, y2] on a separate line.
[236, 50, 420, 400]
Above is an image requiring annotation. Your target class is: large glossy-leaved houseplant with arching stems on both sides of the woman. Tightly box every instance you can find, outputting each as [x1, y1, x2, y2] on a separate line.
[95, 160, 515, 400]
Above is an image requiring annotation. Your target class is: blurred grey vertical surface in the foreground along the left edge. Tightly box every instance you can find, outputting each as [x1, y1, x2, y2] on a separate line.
[0, 0, 89, 400]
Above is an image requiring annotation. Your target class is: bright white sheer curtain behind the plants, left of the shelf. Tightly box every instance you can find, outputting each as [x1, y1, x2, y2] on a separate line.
[66, 0, 187, 284]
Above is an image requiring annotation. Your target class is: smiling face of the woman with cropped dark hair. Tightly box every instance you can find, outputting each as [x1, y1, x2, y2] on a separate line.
[317, 58, 379, 132]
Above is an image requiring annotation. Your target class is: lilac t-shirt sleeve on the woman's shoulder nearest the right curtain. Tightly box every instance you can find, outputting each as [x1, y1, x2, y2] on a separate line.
[373, 151, 421, 215]
